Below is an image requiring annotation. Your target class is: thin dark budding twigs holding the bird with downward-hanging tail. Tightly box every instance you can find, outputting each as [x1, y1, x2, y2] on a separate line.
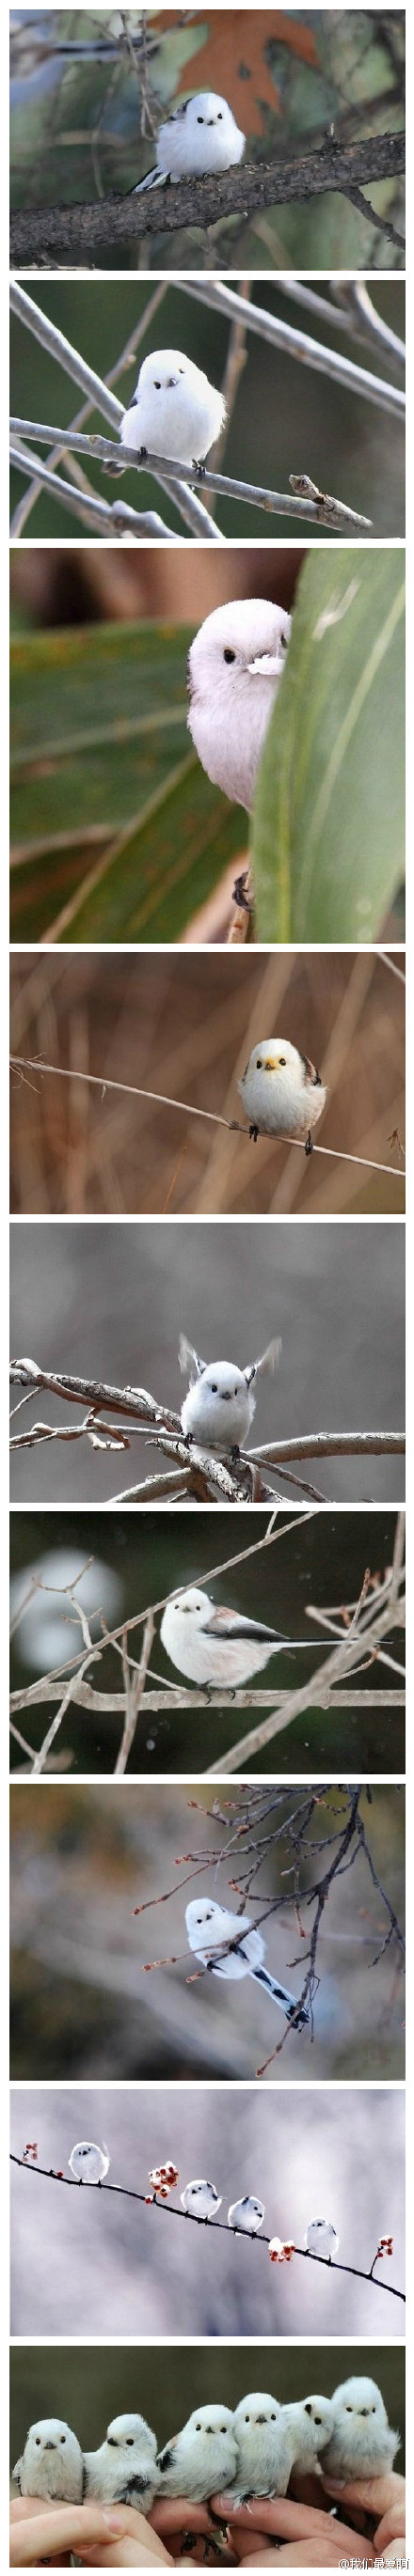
[134, 1783, 404, 2076]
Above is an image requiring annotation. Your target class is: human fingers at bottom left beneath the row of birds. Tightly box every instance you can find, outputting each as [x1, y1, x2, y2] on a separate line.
[10, 2496, 175, 2568]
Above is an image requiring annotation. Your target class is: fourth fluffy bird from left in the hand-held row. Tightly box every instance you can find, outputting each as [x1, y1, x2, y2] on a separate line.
[231, 2388, 294, 2504]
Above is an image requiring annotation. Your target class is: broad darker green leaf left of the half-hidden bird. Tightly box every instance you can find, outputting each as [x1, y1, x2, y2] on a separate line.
[10, 621, 245, 943]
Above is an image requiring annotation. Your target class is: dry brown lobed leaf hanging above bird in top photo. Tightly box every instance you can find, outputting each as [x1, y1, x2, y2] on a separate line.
[154, 8, 316, 134]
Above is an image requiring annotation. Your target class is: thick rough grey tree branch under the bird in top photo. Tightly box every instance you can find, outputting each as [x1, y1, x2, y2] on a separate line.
[10, 134, 406, 268]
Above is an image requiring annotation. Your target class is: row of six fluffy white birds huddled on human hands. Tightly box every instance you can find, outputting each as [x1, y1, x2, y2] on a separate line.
[13, 2378, 399, 2514]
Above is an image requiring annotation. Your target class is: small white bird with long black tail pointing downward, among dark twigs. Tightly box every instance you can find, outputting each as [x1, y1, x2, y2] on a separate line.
[185, 1896, 309, 2030]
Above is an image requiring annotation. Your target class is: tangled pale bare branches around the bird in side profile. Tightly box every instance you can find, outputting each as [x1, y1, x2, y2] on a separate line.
[10, 1504, 404, 1777]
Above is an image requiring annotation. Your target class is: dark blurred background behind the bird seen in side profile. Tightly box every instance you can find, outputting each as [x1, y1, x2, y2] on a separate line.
[10, 1509, 404, 1780]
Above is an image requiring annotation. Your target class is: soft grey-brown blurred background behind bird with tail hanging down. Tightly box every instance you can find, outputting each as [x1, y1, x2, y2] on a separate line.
[10, 1780, 404, 2091]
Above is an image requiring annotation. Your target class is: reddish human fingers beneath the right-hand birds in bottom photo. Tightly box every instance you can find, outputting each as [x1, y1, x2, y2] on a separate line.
[214, 2496, 375, 2568]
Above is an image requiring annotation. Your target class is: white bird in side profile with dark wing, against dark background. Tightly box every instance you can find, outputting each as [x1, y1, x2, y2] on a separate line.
[159, 1585, 313, 1697]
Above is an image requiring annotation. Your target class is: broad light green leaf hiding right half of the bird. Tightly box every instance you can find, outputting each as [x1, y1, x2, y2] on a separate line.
[252, 546, 404, 943]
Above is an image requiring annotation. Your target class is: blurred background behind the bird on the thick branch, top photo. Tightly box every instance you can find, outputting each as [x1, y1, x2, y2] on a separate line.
[10, 8, 404, 268]
